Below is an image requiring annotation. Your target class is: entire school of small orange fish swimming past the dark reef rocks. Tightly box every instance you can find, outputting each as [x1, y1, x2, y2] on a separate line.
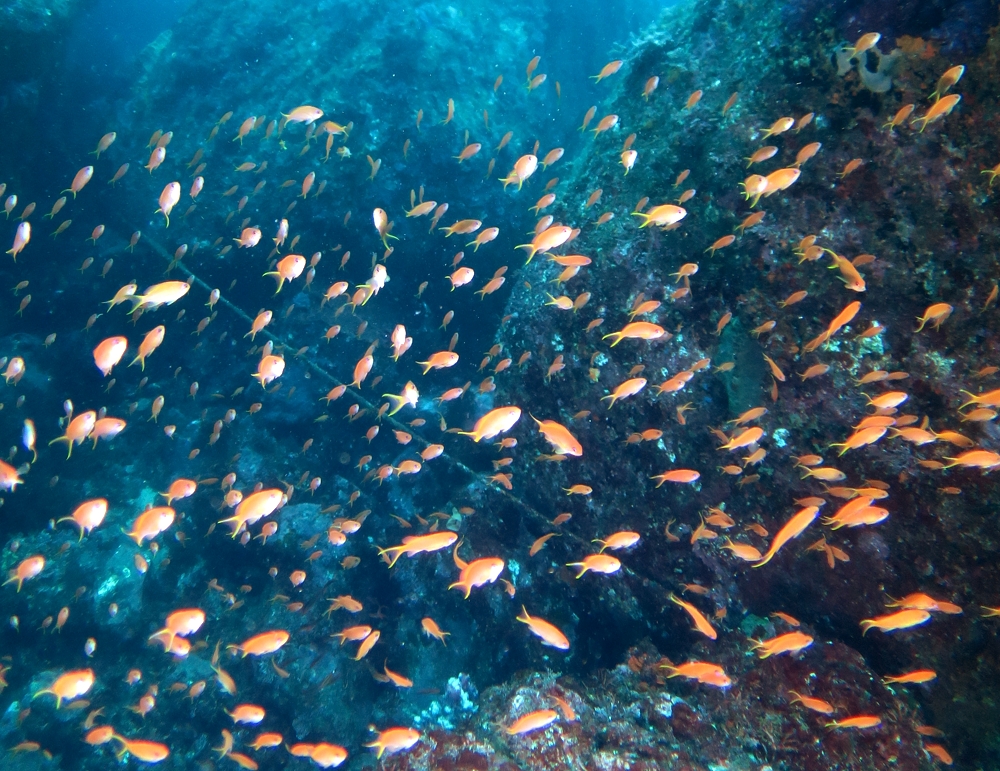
[0, 28, 1000, 769]
